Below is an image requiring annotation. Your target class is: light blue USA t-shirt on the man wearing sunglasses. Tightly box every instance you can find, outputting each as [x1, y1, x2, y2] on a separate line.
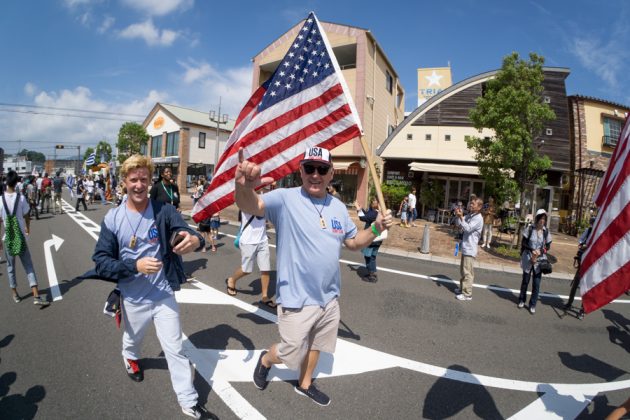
[262, 187, 357, 308]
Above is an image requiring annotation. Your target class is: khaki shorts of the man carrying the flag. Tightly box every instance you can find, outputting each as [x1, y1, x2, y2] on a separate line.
[277, 298, 341, 370]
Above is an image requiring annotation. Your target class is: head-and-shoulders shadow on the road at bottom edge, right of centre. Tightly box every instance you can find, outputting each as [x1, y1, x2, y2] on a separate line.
[422, 365, 504, 419]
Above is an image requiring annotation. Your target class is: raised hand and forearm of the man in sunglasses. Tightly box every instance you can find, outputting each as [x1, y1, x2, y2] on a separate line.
[234, 148, 273, 217]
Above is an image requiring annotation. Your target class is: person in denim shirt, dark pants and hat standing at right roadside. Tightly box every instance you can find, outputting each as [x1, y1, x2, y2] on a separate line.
[518, 209, 551, 315]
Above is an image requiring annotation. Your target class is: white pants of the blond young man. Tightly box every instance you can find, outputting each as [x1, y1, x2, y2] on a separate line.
[122, 296, 197, 407]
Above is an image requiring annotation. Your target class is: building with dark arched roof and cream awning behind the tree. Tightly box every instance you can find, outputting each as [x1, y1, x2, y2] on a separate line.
[376, 67, 571, 226]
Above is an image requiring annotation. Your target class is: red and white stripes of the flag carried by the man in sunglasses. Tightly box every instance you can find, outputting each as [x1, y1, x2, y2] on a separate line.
[192, 14, 361, 222]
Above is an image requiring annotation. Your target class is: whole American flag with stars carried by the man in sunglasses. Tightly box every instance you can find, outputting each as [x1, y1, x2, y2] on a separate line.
[193, 12, 362, 222]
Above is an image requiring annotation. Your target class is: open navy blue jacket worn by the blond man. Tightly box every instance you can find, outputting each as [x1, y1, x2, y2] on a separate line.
[91, 201, 205, 291]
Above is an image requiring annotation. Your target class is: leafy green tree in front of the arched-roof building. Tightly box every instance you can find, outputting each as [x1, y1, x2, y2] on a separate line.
[466, 52, 555, 221]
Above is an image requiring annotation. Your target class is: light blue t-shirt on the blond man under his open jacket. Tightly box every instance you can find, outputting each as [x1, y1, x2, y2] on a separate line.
[105, 201, 173, 303]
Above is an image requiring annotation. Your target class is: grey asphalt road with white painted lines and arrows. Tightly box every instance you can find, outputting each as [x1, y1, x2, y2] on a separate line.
[0, 193, 630, 419]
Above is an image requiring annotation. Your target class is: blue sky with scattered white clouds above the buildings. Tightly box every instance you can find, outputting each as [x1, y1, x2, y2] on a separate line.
[0, 0, 630, 156]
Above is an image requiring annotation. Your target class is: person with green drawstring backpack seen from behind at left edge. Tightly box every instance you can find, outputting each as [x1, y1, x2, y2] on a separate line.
[0, 171, 49, 306]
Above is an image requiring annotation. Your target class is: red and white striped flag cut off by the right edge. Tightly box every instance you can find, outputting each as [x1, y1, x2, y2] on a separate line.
[580, 118, 630, 313]
